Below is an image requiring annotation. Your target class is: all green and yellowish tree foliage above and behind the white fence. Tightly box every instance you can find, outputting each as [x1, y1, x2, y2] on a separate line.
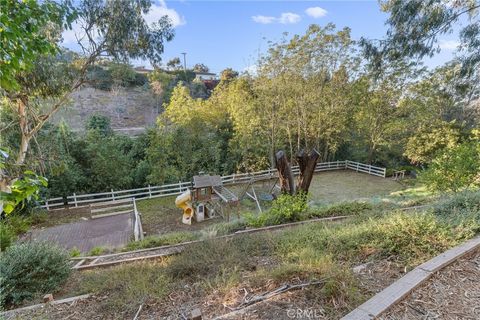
[0, 0, 480, 196]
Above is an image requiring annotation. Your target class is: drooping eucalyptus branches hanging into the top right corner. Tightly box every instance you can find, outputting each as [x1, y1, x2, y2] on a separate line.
[361, 0, 480, 74]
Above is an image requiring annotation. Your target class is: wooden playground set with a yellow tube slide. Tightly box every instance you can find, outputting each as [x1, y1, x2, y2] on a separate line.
[175, 175, 239, 224]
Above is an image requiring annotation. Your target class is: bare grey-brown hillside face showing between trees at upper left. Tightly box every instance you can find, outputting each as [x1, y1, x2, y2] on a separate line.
[53, 87, 161, 135]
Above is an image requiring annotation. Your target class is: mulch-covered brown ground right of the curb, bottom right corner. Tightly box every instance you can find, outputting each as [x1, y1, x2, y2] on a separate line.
[381, 250, 480, 320]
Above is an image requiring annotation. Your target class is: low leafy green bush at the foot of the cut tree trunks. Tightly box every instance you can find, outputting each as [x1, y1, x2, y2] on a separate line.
[245, 194, 307, 227]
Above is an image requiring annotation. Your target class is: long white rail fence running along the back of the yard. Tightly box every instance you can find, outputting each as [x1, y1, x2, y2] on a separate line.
[42, 160, 386, 210]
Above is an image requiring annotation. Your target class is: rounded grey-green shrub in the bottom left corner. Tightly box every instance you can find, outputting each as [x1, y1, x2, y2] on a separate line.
[0, 242, 71, 306]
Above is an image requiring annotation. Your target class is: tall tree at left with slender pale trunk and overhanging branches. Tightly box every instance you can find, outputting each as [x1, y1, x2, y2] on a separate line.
[2, 0, 174, 190]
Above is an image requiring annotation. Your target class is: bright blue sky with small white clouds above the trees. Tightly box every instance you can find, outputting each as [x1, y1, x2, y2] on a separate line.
[64, 0, 457, 72]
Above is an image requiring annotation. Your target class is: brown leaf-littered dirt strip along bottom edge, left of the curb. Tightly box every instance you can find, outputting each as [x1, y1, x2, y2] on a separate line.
[7, 260, 404, 320]
